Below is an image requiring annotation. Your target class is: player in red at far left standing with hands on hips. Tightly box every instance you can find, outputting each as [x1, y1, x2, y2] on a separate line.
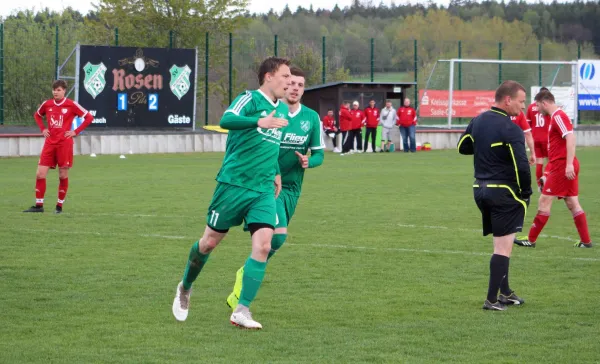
[23, 80, 94, 214]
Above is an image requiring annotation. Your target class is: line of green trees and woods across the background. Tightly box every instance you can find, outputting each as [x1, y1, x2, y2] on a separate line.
[2, 0, 600, 122]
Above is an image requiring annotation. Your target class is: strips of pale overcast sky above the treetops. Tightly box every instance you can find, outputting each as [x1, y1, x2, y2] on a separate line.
[0, 0, 572, 16]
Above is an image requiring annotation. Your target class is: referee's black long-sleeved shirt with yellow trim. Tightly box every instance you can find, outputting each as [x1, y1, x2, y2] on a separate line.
[458, 107, 531, 198]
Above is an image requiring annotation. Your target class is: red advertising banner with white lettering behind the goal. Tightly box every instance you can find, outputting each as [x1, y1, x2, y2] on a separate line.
[419, 90, 496, 118]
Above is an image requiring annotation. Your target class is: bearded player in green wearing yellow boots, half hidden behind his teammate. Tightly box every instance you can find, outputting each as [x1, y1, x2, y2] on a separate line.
[227, 67, 325, 309]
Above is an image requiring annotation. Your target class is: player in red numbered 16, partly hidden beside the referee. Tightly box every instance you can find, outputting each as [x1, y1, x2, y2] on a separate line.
[527, 87, 550, 192]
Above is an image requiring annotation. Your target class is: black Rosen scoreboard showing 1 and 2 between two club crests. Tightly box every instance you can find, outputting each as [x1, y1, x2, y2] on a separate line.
[79, 46, 196, 128]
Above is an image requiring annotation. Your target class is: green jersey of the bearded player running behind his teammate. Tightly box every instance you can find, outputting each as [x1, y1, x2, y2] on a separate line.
[279, 105, 325, 195]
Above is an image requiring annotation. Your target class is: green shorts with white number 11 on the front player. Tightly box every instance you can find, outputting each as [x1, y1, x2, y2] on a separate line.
[206, 182, 277, 231]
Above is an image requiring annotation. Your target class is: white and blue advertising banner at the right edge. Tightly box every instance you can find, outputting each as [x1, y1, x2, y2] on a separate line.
[577, 59, 600, 111]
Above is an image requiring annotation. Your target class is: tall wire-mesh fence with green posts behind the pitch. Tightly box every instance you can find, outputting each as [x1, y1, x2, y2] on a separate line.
[0, 23, 600, 125]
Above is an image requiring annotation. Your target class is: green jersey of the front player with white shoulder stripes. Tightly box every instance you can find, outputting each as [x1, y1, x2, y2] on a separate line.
[216, 90, 288, 192]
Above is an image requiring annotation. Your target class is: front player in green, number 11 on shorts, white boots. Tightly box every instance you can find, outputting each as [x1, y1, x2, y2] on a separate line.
[173, 57, 291, 329]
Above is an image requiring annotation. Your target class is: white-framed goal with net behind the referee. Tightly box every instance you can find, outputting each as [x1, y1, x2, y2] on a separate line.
[417, 59, 578, 128]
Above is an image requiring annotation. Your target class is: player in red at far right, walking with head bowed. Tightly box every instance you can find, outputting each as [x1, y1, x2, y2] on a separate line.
[515, 91, 592, 248]
